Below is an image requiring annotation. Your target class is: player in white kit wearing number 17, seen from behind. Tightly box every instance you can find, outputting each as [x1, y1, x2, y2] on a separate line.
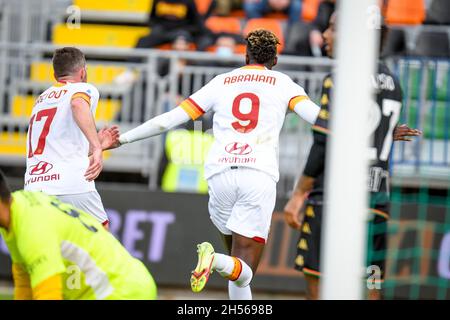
[25, 47, 118, 227]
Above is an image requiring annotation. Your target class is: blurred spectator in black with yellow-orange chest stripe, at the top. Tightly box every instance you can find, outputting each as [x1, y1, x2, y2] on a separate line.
[136, 0, 212, 50]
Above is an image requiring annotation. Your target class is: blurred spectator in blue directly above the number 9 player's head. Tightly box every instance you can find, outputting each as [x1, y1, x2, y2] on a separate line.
[244, 0, 302, 24]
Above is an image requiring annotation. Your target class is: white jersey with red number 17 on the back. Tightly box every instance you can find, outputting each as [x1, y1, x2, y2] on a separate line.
[24, 82, 99, 195]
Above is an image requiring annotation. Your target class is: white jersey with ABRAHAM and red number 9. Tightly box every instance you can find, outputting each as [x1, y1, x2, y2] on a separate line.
[180, 65, 320, 181]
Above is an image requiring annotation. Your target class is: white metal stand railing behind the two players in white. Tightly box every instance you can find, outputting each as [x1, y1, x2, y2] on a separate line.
[0, 43, 332, 194]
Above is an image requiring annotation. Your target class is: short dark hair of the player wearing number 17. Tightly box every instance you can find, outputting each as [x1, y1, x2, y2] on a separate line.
[53, 47, 86, 78]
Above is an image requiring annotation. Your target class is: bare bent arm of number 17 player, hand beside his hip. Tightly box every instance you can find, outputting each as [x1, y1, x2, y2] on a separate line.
[71, 98, 103, 181]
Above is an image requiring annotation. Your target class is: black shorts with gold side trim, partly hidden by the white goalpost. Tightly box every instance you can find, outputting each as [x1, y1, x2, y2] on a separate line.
[295, 201, 388, 279]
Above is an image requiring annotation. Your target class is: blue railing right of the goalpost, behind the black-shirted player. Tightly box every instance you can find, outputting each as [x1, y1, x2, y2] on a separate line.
[392, 58, 450, 186]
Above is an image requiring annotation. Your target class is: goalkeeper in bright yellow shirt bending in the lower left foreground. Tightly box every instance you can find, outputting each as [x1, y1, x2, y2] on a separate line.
[0, 171, 156, 300]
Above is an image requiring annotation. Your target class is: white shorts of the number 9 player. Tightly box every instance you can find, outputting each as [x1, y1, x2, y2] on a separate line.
[208, 167, 276, 243]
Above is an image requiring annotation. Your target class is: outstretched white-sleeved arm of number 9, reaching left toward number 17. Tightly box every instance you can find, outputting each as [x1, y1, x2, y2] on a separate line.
[114, 107, 191, 147]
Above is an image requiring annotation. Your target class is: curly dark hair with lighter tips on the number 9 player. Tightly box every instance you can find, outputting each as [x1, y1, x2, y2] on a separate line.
[245, 29, 280, 64]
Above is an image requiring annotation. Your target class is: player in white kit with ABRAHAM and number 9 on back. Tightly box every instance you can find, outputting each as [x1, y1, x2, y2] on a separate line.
[111, 30, 320, 299]
